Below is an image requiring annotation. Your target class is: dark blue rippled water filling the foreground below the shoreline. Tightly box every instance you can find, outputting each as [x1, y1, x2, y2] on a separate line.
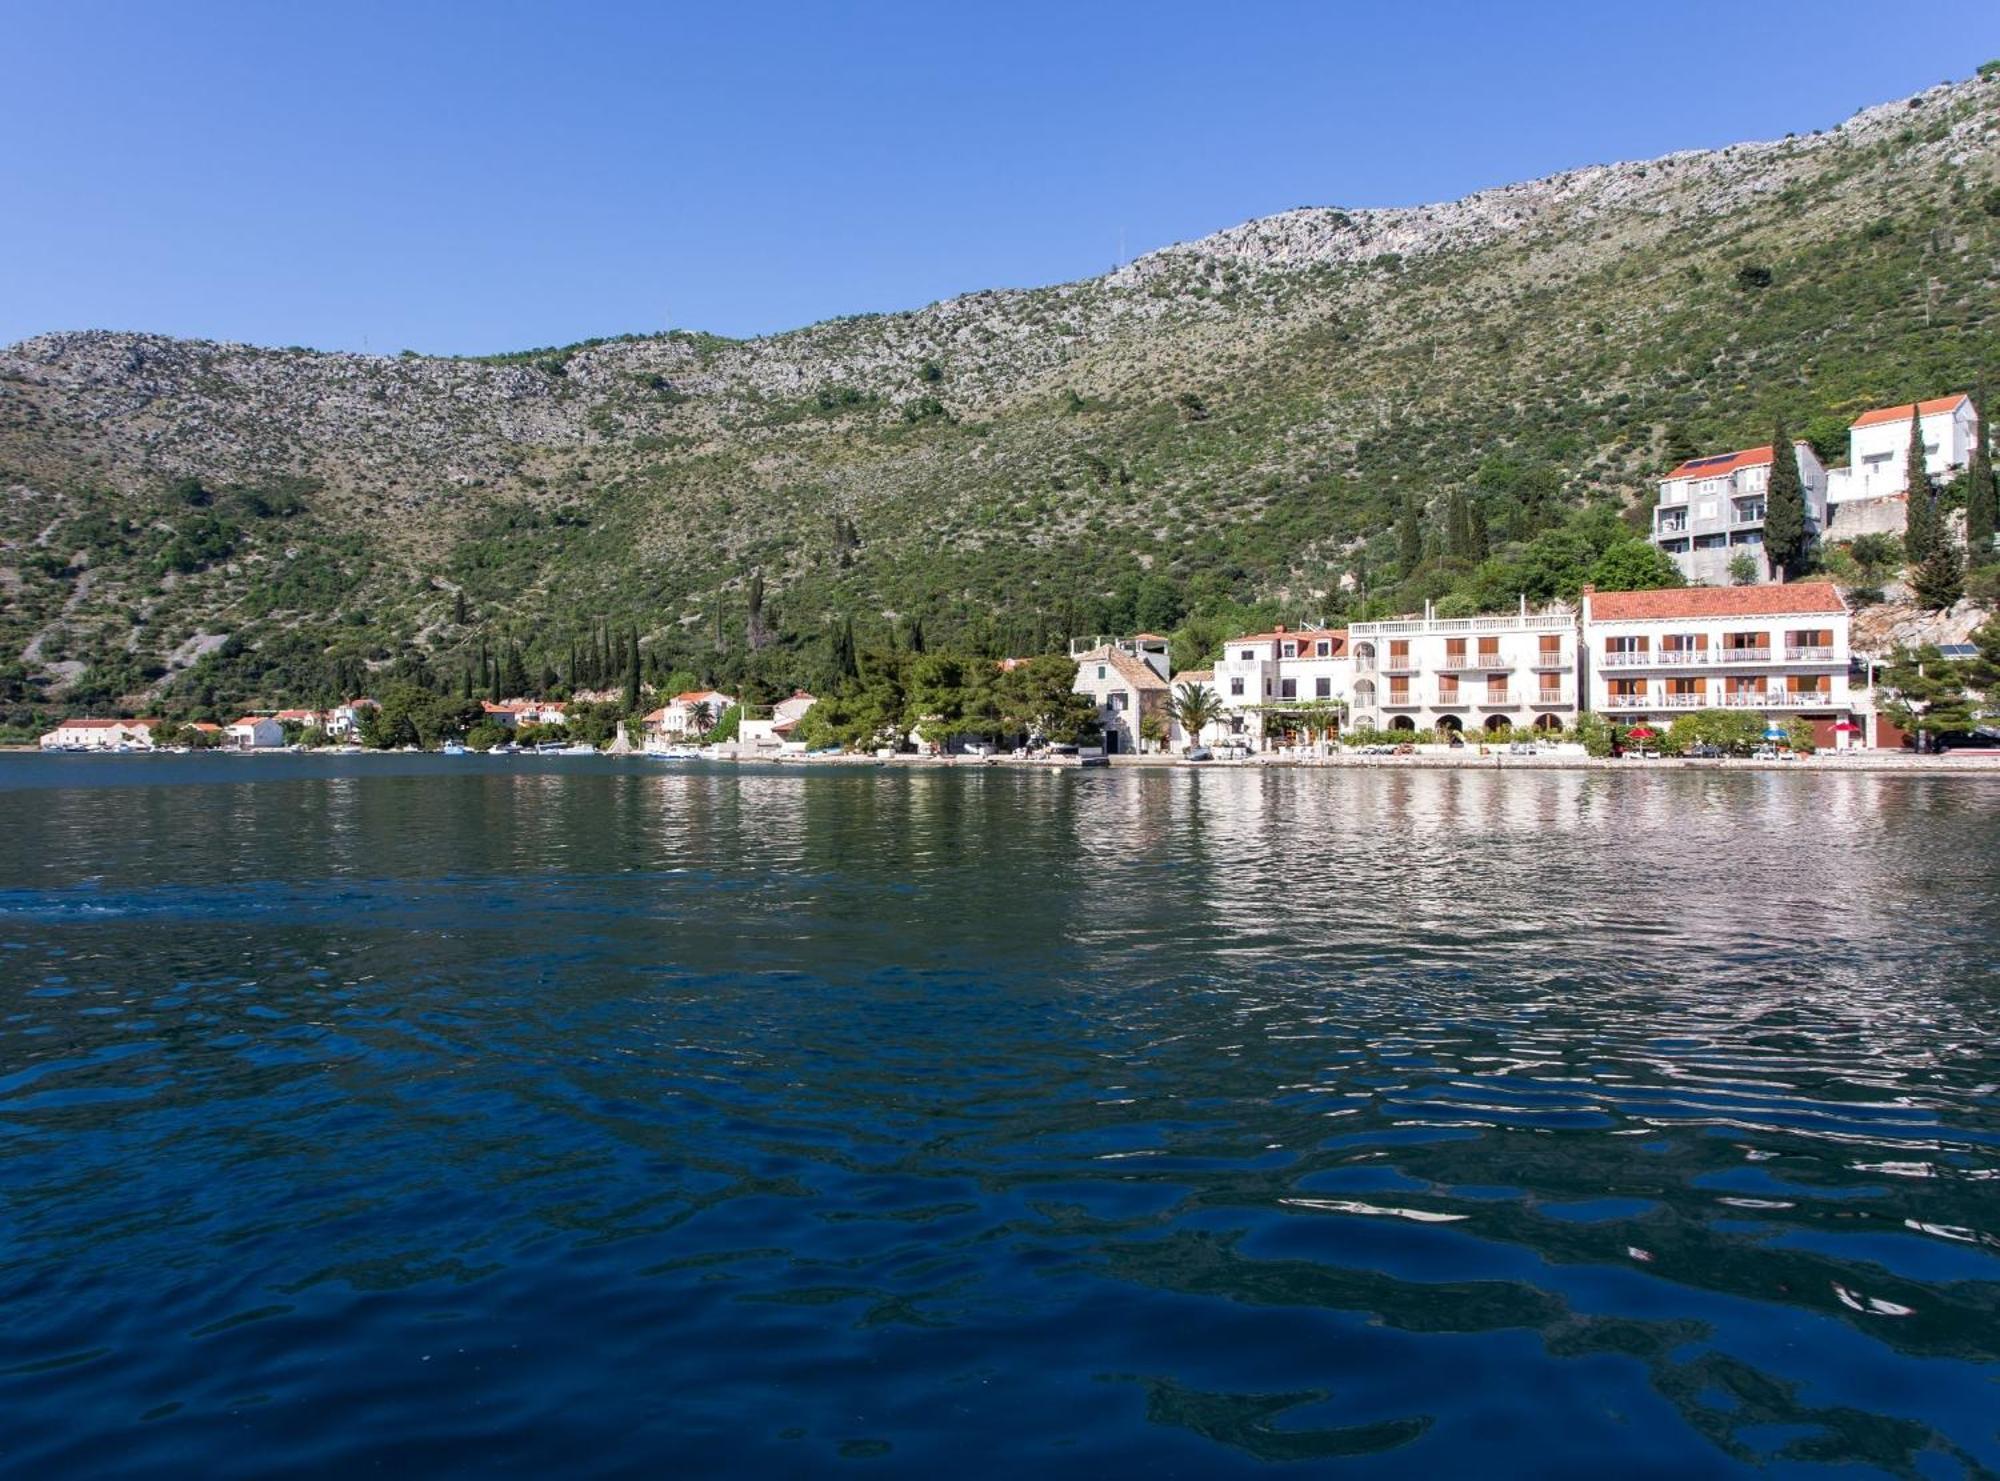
[0, 759, 2000, 1475]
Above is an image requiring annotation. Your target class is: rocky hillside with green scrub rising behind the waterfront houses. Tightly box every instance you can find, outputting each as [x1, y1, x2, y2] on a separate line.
[0, 74, 2000, 714]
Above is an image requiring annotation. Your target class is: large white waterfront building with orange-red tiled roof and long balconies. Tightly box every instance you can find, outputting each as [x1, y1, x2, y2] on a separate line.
[1582, 580, 1854, 749]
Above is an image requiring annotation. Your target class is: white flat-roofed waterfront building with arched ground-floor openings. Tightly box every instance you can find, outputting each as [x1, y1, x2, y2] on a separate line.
[1348, 602, 1578, 736]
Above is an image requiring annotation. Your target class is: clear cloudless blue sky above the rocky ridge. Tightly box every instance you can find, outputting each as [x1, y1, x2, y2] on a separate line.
[0, 0, 2000, 354]
